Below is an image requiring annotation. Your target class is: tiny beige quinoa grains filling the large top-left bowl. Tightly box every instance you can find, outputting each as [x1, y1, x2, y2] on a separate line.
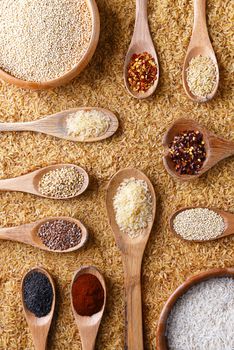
[0, 0, 92, 82]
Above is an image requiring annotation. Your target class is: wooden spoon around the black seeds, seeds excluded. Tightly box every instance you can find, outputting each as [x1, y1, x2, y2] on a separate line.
[21, 267, 56, 350]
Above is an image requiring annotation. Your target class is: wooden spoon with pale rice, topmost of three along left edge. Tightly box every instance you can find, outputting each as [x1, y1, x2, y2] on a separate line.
[0, 107, 119, 142]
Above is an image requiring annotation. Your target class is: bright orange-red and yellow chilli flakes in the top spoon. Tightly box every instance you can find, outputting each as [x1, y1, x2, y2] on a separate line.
[127, 52, 157, 93]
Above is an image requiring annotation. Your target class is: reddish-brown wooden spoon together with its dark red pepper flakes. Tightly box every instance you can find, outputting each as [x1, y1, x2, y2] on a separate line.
[163, 118, 234, 181]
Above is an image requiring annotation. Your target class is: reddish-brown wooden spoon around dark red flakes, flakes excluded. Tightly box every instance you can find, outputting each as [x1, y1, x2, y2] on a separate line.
[163, 119, 234, 181]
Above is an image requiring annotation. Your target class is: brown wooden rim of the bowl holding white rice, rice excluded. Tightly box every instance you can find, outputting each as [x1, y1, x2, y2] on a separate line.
[156, 268, 234, 350]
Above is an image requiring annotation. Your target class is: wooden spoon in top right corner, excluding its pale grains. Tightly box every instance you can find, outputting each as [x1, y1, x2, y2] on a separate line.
[182, 0, 219, 102]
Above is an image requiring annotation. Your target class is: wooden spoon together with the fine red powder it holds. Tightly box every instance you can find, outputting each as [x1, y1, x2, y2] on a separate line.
[70, 266, 106, 350]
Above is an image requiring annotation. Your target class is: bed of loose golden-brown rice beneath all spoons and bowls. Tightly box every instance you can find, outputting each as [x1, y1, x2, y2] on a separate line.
[0, 0, 234, 350]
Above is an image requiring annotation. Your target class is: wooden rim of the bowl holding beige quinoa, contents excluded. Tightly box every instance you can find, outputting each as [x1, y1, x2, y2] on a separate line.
[0, 0, 100, 90]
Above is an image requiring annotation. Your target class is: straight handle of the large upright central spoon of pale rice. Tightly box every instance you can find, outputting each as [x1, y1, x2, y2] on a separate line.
[123, 257, 144, 350]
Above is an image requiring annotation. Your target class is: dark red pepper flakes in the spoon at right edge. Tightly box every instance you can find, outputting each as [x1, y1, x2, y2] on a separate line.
[170, 130, 206, 175]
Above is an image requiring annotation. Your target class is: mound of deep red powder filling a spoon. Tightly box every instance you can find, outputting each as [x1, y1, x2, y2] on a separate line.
[72, 273, 104, 316]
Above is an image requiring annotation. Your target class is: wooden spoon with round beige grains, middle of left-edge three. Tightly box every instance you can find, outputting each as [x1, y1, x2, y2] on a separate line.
[0, 164, 89, 199]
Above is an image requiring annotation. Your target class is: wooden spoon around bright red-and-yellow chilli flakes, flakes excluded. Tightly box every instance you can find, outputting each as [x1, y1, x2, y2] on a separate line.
[124, 0, 159, 99]
